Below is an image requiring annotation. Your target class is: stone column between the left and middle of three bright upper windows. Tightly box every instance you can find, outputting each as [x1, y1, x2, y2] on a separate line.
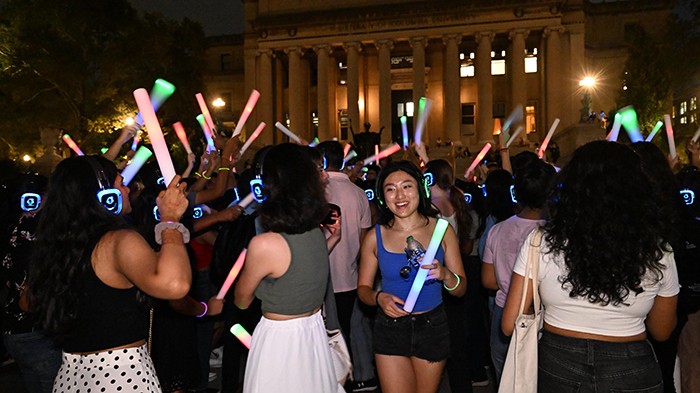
[474, 32, 494, 145]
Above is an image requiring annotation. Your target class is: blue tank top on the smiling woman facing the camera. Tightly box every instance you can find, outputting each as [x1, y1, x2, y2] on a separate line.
[375, 225, 445, 312]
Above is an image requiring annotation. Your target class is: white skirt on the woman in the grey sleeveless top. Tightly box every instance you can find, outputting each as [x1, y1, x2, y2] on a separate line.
[243, 311, 344, 393]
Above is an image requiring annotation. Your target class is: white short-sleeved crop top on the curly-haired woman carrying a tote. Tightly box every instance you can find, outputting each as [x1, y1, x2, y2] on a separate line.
[514, 232, 680, 337]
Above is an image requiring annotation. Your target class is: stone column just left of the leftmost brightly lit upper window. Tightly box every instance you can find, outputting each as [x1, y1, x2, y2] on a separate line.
[442, 34, 462, 141]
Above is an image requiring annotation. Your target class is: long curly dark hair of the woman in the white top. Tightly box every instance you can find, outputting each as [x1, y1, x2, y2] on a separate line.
[544, 141, 667, 306]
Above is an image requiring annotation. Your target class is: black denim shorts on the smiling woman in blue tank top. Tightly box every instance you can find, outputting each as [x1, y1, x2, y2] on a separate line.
[372, 304, 450, 362]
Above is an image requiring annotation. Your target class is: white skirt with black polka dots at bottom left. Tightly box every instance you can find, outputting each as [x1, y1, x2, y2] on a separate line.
[53, 345, 161, 393]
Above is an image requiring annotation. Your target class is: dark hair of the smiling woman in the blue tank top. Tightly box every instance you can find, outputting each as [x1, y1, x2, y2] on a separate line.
[375, 160, 440, 227]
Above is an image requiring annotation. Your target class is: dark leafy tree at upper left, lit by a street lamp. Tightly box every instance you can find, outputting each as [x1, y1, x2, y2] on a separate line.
[0, 0, 206, 159]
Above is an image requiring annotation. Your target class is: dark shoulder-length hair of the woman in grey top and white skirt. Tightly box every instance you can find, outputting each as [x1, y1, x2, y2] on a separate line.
[259, 143, 328, 234]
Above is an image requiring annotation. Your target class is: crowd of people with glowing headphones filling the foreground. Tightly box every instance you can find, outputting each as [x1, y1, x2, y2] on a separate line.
[0, 123, 700, 393]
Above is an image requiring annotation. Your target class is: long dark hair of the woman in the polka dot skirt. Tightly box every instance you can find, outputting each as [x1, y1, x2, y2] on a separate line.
[29, 156, 127, 338]
